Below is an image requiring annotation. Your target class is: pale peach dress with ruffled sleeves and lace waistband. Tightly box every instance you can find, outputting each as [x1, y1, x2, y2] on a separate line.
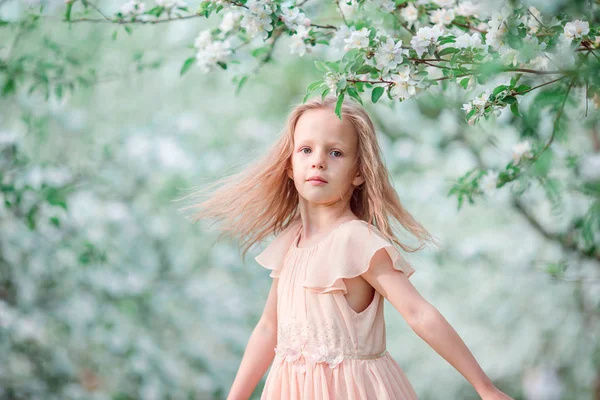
[255, 218, 417, 400]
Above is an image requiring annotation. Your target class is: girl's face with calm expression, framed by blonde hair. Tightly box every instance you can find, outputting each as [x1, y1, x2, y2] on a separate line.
[288, 108, 364, 205]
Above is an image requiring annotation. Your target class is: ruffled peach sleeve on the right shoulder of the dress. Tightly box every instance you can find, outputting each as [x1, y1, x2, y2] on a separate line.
[304, 220, 415, 294]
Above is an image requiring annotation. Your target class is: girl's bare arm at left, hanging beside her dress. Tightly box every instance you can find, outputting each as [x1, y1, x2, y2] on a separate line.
[227, 278, 279, 400]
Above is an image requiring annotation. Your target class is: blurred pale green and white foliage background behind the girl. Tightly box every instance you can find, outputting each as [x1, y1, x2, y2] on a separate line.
[0, 0, 600, 400]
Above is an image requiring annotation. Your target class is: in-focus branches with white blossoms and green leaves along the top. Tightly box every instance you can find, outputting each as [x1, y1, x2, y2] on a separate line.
[65, 0, 600, 259]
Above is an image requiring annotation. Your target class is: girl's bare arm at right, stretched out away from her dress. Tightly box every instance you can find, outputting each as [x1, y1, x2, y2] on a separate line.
[362, 249, 511, 400]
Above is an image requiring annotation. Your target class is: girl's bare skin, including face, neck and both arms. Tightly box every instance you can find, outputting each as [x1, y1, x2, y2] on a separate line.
[227, 109, 512, 400]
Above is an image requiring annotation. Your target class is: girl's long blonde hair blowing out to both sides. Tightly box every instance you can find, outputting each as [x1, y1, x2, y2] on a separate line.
[180, 96, 435, 259]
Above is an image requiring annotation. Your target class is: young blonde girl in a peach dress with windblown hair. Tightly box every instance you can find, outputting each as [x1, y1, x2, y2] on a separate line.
[182, 98, 510, 400]
